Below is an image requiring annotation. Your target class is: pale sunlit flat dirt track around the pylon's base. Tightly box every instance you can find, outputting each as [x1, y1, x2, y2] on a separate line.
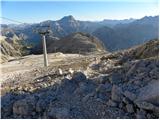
[0, 53, 97, 81]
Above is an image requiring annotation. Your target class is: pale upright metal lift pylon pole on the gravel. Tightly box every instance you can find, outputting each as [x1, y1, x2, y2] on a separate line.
[42, 35, 48, 67]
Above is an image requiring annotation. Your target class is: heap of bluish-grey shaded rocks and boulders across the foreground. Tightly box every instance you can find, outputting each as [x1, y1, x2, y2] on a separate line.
[1, 39, 159, 119]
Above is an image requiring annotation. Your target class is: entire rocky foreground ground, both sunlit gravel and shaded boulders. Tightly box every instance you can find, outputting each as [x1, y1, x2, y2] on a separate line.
[1, 40, 159, 119]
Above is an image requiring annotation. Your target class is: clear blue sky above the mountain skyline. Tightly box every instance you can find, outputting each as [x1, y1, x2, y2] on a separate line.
[1, 0, 158, 23]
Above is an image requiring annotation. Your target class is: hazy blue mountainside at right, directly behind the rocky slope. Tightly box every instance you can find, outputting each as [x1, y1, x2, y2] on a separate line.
[93, 16, 159, 51]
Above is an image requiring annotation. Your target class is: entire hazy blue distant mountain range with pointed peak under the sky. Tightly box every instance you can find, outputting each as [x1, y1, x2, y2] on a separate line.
[2, 15, 159, 51]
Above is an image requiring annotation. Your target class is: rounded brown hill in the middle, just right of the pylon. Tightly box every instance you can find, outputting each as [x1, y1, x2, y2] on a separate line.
[48, 33, 105, 53]
